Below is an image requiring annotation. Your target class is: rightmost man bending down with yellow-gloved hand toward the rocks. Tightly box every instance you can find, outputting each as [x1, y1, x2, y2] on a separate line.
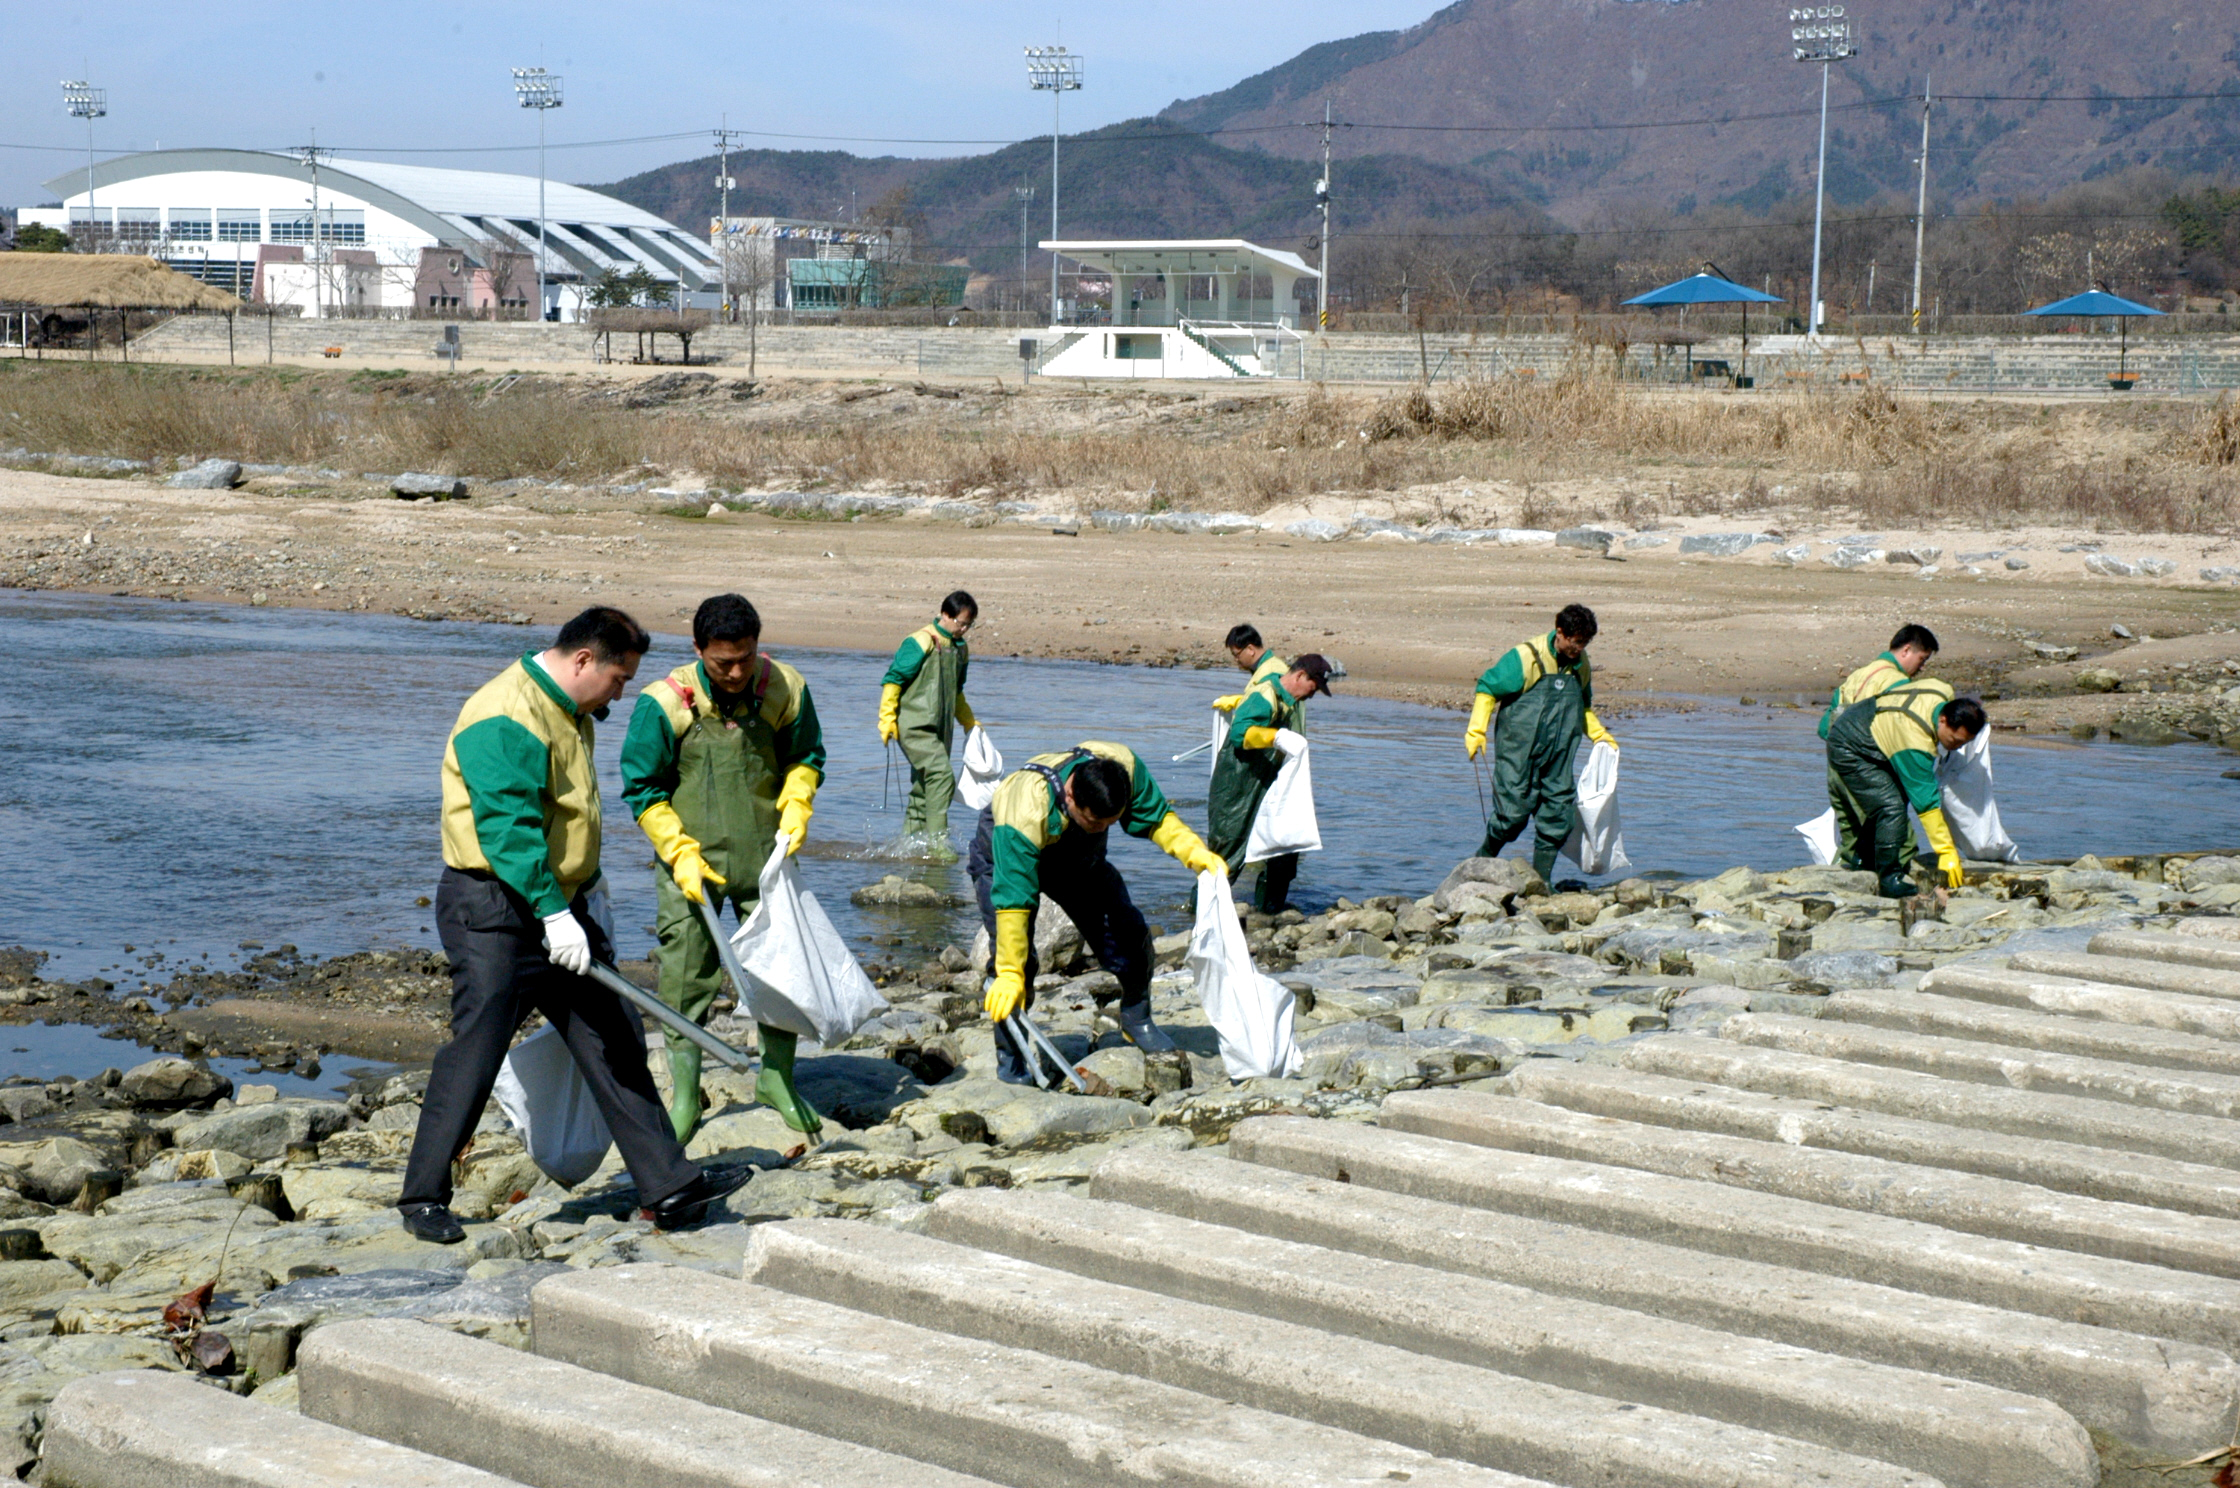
[1828, 677, 1985, 899]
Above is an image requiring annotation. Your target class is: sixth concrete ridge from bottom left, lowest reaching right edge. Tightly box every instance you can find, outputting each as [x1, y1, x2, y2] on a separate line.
[1088, 1152, 2240, 1454]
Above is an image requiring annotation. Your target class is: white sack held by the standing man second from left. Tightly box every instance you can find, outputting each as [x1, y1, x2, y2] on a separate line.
[730, 834, 887, 1049]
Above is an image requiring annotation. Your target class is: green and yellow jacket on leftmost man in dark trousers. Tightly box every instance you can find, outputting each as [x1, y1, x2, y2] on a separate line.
[444, 652, 598, 919]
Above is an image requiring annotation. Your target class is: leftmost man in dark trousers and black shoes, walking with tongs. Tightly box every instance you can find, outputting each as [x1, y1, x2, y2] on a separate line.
[396, 605, 721, 1244]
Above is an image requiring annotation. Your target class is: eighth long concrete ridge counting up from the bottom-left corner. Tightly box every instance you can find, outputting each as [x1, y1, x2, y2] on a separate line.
[1380, 1087, 2240, 1298]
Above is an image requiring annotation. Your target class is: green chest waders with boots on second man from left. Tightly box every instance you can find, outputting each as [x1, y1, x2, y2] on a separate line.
[654, 672, 822, 1141]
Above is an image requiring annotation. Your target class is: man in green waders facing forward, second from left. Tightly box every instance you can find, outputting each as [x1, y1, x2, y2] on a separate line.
[623, 594, 824, 1141]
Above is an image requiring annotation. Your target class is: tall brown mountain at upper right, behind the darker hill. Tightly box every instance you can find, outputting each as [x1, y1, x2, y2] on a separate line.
[1160, 0, 2240, 222]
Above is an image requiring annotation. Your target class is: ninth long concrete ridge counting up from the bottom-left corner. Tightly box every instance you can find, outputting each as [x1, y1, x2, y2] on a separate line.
[1496, 1060, 2240, 1219]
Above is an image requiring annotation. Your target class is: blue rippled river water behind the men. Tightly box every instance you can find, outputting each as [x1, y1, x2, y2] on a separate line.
[0, 592, 2240, 1012]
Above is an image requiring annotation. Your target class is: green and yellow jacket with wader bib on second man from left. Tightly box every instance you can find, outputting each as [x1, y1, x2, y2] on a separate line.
[623, 657, 824, 899]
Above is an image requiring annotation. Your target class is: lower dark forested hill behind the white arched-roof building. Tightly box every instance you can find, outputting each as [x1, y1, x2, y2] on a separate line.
[596, 119, 1546, 269]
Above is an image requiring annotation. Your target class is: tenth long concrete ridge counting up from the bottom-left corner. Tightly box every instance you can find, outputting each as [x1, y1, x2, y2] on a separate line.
[1626, 1038, 2240, 1168]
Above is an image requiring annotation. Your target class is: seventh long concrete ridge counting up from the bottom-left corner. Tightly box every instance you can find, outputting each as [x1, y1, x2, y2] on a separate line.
[1230, 1116, 2240, 1351]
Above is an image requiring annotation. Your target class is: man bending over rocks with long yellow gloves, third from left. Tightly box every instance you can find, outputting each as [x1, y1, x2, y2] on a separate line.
[968, 740, 1225, 1085]
